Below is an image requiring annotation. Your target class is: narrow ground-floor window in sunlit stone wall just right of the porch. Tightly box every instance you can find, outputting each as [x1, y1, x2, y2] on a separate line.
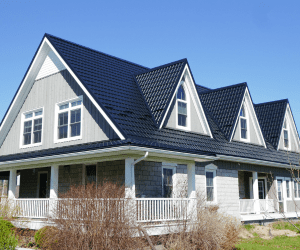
[205, 164, 217, 202]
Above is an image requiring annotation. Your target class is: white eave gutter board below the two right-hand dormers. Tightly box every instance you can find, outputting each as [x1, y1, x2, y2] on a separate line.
[217, 154, 300, 169]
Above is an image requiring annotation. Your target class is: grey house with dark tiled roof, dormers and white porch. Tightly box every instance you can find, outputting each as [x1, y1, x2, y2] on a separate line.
[0, 34, 300, 229]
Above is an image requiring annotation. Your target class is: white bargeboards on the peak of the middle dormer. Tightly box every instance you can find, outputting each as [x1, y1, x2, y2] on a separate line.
[230, 87, 267, 148]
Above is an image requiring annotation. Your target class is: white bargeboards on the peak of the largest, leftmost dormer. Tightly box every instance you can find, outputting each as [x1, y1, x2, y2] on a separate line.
[159, 64, 213, 138]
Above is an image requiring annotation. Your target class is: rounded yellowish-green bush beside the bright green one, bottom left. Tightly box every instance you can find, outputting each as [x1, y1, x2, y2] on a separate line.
[34, 226, 58, 249]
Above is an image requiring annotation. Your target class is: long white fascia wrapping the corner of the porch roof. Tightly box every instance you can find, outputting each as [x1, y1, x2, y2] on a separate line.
[0, 146, 218, 170]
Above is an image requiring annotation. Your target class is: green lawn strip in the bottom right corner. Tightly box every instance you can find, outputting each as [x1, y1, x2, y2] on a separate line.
[236, 236, 300, 250]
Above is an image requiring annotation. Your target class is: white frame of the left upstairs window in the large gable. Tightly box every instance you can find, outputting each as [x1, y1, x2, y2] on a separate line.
[19, 107, 45, 149]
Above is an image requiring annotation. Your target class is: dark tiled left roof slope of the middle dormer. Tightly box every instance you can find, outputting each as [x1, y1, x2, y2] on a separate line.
[199, 83, 247, 141]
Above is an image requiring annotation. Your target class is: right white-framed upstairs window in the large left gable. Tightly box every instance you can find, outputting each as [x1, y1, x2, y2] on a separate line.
[54, 97, 83, 142]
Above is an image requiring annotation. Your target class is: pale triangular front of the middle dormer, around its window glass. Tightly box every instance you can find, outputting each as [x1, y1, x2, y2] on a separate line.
[231, 87, 266, 147]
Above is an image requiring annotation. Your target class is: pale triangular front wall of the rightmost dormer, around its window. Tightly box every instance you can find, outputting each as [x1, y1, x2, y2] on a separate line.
[277, 103, 300, 152]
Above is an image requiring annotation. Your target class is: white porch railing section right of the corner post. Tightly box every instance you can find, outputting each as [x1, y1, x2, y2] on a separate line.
[136, 198, 192, 222]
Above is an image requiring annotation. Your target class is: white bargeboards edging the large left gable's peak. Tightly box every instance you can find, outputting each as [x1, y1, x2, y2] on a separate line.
[0, 34, 125, 145]
